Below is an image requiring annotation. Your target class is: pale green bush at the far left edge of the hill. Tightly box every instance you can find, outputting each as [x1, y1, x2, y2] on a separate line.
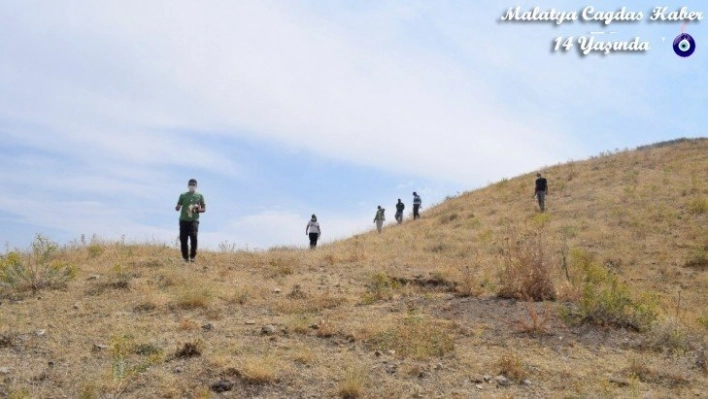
[0, 234, 78, 291]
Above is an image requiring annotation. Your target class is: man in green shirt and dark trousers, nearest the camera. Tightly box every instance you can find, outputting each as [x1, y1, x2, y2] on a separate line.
[175, 179, 206, 262]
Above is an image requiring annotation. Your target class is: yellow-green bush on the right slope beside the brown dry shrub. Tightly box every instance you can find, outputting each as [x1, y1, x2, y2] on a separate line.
[565, 249, 657, 331]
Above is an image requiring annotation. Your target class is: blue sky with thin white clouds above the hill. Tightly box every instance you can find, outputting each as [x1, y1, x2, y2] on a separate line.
[0, 0, 708, 249]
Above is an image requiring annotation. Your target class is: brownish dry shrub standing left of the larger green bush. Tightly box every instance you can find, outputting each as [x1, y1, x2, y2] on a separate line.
[497, 226, 556, 301]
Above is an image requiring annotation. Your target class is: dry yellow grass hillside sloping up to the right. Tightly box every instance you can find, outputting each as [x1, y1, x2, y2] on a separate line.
[0, 139, 708, 398]
